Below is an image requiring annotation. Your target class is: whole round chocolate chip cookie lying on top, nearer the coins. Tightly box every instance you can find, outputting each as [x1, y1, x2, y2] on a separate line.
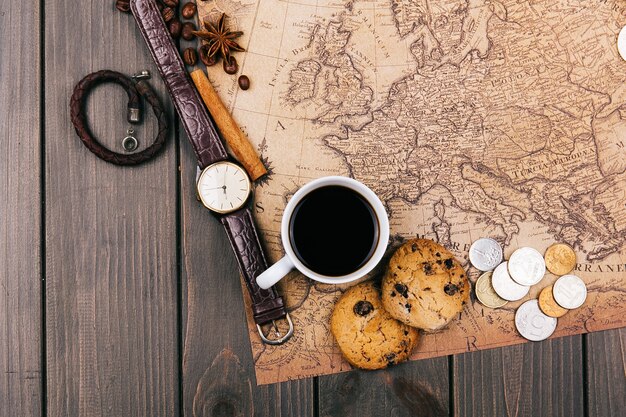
[382, 239, 470, 331]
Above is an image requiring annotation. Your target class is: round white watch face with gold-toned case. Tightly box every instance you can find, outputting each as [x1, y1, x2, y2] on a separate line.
[198, 162, 250, 213]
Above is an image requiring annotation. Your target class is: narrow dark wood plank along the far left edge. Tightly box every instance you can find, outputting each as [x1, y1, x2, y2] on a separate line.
[0, 1, 42, 417]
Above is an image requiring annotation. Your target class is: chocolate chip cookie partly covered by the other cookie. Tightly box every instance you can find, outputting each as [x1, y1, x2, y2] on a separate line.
[330, 282, 418, 369]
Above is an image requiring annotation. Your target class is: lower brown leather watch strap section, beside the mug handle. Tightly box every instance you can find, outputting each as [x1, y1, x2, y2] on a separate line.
[221, 207, 287, 324]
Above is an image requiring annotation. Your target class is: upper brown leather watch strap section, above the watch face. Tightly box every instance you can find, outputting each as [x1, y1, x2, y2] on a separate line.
[130, 0, 228, 168]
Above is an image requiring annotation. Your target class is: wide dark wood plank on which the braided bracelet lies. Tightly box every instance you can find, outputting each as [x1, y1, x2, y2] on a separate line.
[44, 0, 179, 417]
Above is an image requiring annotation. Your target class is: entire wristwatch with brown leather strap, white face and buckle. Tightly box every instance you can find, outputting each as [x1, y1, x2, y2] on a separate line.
[130, 0, 293, 345]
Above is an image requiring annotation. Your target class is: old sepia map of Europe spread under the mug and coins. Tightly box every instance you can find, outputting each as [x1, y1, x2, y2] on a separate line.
[198, 0, 626, 384]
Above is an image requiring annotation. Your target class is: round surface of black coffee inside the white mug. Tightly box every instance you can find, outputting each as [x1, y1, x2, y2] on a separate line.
[289, 185, 379, 277]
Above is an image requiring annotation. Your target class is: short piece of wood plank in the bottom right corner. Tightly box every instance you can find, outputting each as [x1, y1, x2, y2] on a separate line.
[585, 329, 626, 417]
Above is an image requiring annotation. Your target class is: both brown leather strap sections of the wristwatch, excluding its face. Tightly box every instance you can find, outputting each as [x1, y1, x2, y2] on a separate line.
[130, 0, 288, 326]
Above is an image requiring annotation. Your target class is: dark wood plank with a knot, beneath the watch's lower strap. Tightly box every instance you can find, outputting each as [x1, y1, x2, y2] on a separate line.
[180, 127, 315, 417]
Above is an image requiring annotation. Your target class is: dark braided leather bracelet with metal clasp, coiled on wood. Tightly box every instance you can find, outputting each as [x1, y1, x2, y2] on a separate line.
[70, 70, 168, 165]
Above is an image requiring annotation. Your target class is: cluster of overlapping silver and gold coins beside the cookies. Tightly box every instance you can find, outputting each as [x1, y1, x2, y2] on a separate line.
[469, 238, 587, 341]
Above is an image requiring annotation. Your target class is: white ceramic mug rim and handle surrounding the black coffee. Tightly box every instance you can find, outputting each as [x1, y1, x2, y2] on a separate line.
[257, 176, 389, 289]
